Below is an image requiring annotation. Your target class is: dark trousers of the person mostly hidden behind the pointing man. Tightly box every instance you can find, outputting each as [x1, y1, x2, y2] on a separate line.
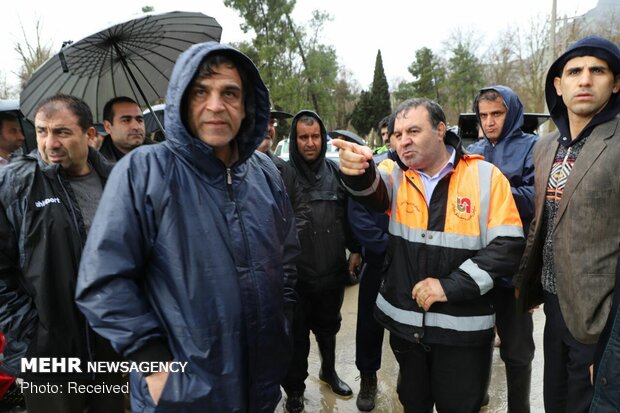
[355, 264, 383, 373]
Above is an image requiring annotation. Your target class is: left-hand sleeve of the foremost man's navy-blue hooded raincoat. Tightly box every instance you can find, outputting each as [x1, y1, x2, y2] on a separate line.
[76, 159, 171, 361]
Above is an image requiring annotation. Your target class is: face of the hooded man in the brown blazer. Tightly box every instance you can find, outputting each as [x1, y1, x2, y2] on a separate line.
[553, 56, 620, 120]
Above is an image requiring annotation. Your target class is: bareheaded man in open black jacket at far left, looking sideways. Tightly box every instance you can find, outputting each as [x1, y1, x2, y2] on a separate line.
[0, 95, 124, 413]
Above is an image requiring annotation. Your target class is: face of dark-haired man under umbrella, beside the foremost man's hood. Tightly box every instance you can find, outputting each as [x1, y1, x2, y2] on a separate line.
[103, 102, 146, 153]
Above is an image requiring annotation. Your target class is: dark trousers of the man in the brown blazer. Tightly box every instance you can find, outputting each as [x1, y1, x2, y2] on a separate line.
[543, 293, 596, 413]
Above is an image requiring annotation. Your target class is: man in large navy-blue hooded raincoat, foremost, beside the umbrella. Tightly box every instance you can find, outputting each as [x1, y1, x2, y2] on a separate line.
[77, 42, 299, 413]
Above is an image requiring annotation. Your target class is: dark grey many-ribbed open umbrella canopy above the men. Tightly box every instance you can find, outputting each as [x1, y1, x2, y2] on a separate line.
[20, 11, 222, 122]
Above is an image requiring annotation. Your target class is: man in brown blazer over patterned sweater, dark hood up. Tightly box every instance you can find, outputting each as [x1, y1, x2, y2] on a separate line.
[514, 36, 620, 413]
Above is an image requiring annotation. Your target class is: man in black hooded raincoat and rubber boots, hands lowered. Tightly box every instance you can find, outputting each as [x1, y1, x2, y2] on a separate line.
[282, 110, 361, 413]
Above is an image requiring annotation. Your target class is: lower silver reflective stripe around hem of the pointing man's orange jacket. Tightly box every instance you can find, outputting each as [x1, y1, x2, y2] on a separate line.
[377, 293, 495, 332]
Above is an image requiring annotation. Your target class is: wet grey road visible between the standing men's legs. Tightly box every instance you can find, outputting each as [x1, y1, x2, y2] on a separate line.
[276, 285, 544, 413]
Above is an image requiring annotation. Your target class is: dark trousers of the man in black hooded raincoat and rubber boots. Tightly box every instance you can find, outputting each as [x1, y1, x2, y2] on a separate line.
[282, 286, 344, 393]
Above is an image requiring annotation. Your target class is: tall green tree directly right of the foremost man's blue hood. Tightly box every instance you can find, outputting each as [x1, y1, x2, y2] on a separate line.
[224, 0, 338, 131]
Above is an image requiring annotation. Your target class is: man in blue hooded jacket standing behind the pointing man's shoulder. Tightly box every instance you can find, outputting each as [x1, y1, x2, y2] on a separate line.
[467, 85, 538, 413]
